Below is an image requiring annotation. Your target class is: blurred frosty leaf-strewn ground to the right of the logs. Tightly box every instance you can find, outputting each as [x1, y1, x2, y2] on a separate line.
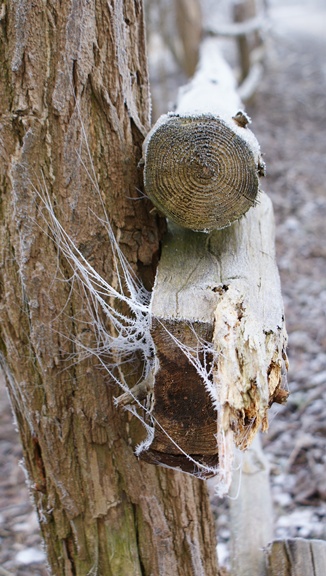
[252, 2, 326, 539]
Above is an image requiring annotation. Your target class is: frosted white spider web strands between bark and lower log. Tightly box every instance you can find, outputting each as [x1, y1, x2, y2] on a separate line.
[31, 99, 233, 496]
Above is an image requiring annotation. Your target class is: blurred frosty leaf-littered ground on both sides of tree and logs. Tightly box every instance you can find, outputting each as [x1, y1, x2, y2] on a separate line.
[0, 0, 326, 576]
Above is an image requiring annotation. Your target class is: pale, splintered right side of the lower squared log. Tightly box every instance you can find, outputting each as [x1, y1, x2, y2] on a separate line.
[210, 193, 287, 448]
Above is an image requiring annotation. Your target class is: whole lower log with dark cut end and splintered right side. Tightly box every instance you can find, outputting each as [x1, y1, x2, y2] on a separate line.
[142, 193, 287, 477]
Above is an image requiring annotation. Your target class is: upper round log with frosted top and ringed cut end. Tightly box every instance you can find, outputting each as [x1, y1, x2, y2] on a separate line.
[144, 40, 264, 231]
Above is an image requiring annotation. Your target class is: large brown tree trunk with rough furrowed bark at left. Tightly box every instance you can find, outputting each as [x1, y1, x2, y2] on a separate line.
[0, 0, 217, 576]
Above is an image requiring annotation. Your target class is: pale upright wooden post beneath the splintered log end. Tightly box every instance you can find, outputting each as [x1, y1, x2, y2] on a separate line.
[230, 434, 273, 576]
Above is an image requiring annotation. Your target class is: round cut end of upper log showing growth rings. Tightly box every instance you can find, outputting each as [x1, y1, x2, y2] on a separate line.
[144, 115, 259, 231]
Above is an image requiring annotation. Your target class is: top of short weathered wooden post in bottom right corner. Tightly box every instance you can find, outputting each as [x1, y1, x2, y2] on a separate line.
[266, 538, 326, 576]
